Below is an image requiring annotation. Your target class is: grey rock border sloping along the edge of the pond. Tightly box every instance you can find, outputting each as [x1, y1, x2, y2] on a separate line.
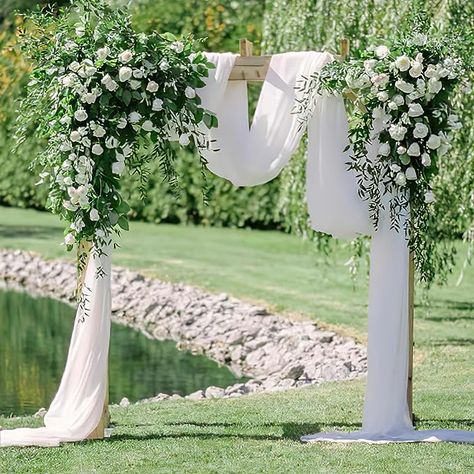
[0, 250, 367, 406]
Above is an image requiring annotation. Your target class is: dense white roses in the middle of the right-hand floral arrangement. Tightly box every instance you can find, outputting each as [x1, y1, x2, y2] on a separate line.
[358, 41, 462, 195]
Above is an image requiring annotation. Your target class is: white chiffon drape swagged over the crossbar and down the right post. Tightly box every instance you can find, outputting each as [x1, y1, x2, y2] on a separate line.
[199, 52, 474, 442]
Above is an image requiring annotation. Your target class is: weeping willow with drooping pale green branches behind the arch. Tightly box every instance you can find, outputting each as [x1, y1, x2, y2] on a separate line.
[263, 0, 474, 286]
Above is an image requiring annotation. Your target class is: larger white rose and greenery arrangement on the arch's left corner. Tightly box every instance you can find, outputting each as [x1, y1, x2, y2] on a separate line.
[14, 0, 217, 262]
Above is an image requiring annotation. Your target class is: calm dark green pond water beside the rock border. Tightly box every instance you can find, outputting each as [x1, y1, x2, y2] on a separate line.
[0, 291, 244, 415]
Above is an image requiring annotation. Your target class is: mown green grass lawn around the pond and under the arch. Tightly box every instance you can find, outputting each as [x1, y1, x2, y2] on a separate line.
[0, 208, 474, 474]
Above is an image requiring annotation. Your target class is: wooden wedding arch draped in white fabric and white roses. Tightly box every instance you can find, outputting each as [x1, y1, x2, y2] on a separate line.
[0, 0, 474, 446]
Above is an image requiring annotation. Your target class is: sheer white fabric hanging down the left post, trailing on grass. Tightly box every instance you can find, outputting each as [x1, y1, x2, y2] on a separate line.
[0, 248, 111, 447]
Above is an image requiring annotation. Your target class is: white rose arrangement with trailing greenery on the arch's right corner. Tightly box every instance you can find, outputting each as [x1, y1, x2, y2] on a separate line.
[296, 32, 468, 279]
